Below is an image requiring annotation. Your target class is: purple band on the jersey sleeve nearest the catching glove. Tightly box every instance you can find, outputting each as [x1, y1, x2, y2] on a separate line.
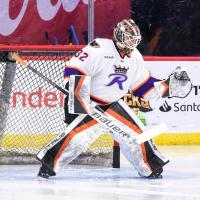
[133, 77, 159, 97]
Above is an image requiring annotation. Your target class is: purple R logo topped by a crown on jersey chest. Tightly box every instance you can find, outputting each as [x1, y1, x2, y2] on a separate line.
[106, 65, 129, 90]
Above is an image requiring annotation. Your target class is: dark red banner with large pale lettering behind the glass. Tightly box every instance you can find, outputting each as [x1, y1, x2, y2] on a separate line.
[0, 0, 131, 44]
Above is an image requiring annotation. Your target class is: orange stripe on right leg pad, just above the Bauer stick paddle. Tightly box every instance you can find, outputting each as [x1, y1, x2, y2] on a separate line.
[106, 109, 142, 134]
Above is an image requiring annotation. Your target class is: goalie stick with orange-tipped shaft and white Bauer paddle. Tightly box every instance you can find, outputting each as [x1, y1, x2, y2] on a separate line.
[11, 53, 167, 144]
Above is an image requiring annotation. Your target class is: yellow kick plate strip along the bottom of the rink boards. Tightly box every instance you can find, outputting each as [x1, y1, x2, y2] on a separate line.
[1, 132, 200, 149]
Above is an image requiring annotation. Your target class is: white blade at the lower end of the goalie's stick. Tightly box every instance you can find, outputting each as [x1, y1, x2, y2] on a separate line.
[136, 123, 167, 144]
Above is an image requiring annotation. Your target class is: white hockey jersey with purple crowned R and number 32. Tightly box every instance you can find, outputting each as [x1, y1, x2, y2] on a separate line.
[64, 39, 150, 105]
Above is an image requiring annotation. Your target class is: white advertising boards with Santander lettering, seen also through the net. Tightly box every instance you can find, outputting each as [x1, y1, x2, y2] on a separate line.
[3, 60, 200, 133]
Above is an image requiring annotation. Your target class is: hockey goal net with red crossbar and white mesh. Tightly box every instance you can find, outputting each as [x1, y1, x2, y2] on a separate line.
[0, 45, 117, 166]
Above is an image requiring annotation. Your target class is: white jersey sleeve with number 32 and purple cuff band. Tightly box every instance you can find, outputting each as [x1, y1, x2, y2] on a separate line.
[64, 39, 101, 78]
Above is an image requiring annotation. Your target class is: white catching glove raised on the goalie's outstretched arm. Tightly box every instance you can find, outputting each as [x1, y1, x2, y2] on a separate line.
[154, 66, 192, 98]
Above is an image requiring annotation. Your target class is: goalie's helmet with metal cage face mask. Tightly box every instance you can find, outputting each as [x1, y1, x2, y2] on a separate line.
[113, 19, 141, 50]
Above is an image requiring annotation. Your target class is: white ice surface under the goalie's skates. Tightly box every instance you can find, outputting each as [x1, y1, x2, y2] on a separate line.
[0, 146, 200, 200]
